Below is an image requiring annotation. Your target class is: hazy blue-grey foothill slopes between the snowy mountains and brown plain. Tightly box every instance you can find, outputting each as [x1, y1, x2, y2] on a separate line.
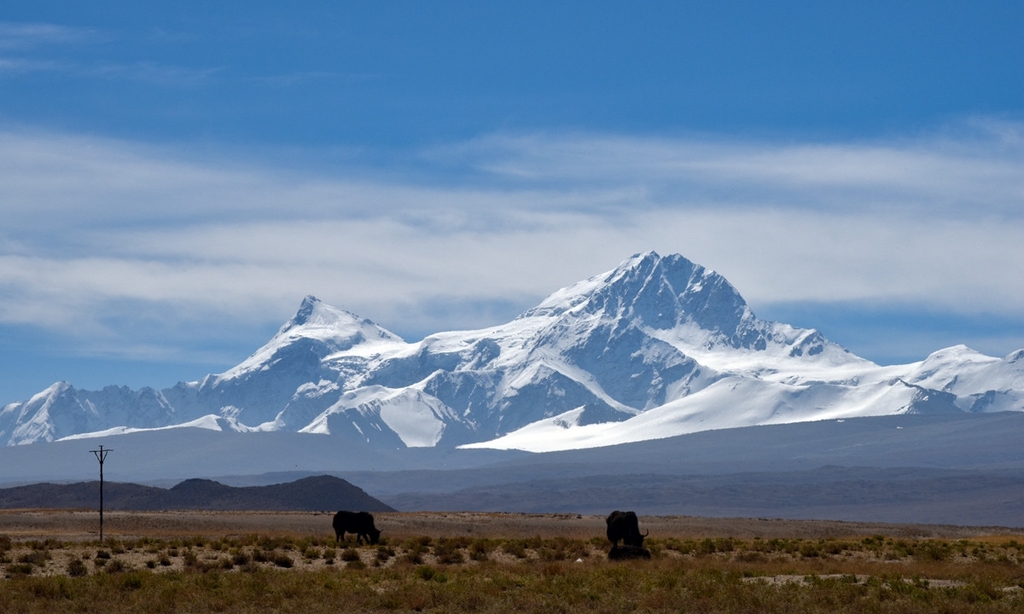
[0, 411, 1024, 527]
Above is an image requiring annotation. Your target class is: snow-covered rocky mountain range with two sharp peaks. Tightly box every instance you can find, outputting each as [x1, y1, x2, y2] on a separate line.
[0, 252, 1024, 451]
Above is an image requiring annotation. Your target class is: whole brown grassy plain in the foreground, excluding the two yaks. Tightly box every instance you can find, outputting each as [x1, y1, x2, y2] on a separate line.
[0, 510, 1024, 614]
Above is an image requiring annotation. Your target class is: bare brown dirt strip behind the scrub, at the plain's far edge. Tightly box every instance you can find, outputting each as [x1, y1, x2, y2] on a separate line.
[0, 510, 1020, 541]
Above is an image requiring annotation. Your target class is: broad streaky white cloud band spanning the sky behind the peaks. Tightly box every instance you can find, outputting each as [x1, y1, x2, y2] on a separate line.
[0, 124, 1024, 360]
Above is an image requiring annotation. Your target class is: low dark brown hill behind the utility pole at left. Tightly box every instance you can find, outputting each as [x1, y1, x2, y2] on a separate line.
[0, 476, 394, 512]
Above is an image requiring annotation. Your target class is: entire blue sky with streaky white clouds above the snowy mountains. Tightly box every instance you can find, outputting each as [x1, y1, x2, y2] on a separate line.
[0, 1, 1024, 404]
